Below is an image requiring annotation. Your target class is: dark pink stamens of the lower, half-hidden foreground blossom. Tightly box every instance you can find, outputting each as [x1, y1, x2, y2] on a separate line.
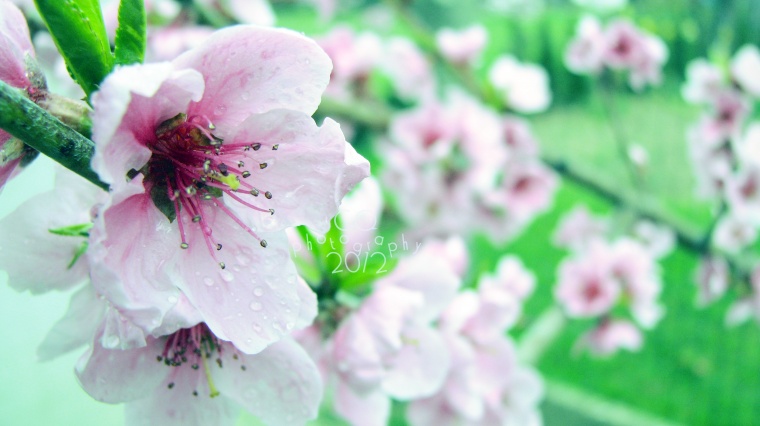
[156, 323, 246, 397]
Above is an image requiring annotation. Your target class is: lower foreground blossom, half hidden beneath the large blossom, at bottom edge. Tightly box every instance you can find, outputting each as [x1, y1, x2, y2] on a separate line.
[76, 323, 322, 425]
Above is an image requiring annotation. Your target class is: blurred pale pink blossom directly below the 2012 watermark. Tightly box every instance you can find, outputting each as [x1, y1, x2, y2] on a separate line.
[317, 245, 459, 425]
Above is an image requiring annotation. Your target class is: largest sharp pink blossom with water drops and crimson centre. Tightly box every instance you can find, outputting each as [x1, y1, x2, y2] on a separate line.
[88, 26, 368, 353]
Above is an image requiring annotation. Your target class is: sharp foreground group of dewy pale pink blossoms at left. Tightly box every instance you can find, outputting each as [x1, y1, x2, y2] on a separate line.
[0, 2, 369, 424]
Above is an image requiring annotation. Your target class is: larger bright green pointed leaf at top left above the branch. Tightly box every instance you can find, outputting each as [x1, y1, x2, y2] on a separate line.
[34, 0, 113, 97]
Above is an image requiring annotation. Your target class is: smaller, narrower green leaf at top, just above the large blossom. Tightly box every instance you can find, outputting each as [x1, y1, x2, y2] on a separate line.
[115, 0, 147, 65]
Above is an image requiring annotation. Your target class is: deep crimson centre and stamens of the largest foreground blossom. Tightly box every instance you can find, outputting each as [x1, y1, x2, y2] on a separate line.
[145, 113, 279, 269]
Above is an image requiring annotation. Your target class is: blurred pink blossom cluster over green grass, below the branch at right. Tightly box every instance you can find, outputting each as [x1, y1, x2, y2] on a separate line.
[555, 207, 675, 356]
